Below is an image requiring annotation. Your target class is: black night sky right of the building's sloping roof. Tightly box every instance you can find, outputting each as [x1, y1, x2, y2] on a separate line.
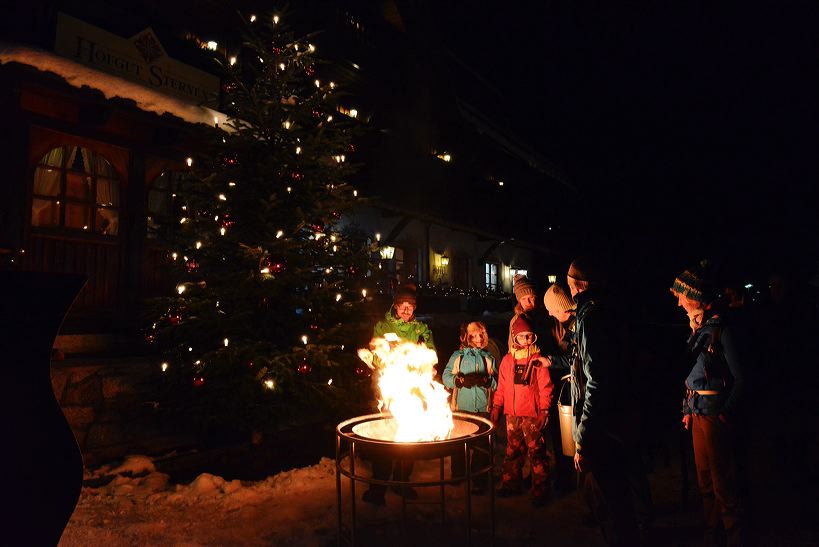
[414, 0, 819, 286]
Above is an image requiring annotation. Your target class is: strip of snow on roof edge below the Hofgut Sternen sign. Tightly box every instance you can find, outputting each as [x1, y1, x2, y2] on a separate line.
[0, 44, 227, 129]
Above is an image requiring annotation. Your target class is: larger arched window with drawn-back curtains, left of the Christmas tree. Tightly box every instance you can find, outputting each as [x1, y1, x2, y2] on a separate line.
[31, 146, 119, 236]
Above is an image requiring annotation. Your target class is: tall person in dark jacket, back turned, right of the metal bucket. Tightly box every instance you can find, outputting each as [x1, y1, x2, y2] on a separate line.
[567, 258, 640, 546]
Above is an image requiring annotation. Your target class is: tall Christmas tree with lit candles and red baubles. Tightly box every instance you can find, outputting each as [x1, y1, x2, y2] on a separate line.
[146, 11, 372, 440]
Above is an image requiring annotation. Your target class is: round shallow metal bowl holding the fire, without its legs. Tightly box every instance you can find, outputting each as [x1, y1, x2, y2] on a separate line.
[336, 412, 495, 459]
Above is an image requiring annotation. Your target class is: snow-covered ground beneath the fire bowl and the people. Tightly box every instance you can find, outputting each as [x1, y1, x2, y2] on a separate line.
[59, 435, 819, 547]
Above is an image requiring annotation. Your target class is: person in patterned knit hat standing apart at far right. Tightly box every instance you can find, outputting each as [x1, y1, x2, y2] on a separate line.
[671, 261, 748, 546]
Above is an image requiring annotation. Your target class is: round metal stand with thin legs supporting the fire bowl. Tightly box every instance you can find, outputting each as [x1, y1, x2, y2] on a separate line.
[336, 412, 495, 546]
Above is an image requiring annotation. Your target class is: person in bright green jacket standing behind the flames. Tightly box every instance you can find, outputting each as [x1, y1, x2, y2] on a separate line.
[361, 283, 435, 505]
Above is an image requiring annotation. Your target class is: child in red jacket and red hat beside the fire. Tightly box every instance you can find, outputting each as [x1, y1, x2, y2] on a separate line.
[491, 315, 553, 507]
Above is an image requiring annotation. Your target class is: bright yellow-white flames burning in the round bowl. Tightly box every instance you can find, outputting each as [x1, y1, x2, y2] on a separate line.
[358, 333, 453, 442]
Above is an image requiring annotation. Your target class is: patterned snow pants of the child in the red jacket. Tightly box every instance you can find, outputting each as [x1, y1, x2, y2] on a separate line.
[502, 414, 550, 497]
